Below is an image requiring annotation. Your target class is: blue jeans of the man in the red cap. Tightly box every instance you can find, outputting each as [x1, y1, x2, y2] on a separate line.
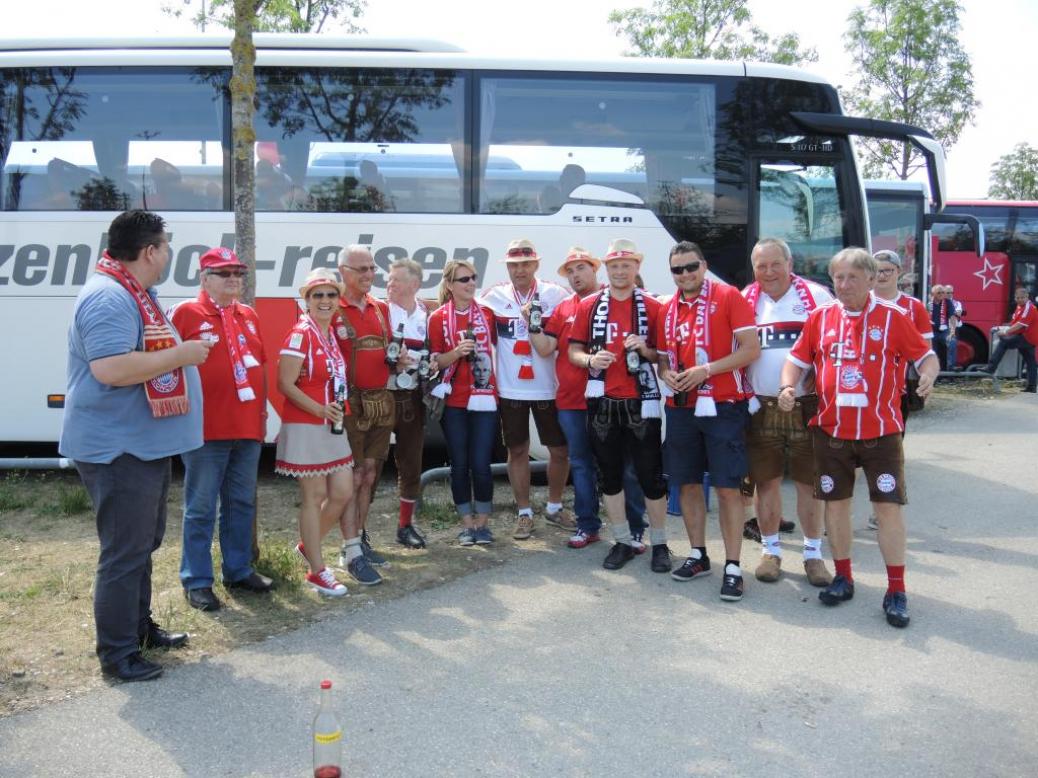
[181, 440, 262, 589]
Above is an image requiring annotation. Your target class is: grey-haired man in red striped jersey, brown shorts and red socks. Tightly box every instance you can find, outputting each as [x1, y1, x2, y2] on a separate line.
[779, 248, 939, 627]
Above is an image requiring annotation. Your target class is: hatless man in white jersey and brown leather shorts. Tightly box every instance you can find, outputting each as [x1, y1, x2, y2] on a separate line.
[742, 238, 832, 586]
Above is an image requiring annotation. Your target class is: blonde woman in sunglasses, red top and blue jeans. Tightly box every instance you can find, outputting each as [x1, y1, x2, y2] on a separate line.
[429, 259, 497, 546]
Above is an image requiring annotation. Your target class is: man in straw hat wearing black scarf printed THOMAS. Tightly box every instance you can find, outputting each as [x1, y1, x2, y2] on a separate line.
[569, 240, 671, 573]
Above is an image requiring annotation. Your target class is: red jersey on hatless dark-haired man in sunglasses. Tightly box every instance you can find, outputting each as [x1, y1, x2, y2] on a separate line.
[656, 282, 757, 408]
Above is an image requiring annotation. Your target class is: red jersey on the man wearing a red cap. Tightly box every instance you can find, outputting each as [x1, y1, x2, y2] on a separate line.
[170, 291, 267, 441]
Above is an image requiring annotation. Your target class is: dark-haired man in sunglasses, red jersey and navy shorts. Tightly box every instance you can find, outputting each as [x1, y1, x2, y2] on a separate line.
[656, 241, 761, 602]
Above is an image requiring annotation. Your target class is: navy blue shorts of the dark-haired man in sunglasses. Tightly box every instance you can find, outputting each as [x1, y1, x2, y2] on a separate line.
[666, 401, 749, 489]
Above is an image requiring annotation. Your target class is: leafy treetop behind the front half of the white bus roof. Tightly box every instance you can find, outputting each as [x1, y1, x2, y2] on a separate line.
[609, 0, 818, 64]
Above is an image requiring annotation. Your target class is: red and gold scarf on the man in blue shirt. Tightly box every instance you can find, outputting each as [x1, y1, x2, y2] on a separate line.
[95, 251, 190, 419]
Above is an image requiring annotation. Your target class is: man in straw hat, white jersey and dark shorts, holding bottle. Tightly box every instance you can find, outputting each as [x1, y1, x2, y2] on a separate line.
[480, 239, 576, 540]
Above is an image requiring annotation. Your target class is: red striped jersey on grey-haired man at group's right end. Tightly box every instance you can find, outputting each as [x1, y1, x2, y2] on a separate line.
[788, 295, 933, 440]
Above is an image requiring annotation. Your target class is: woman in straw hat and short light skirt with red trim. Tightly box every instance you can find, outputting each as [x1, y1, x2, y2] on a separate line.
[274, 268, 353, 596]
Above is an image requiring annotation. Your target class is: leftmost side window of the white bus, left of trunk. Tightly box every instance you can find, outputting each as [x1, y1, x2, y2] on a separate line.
[0, 67, 226, 211]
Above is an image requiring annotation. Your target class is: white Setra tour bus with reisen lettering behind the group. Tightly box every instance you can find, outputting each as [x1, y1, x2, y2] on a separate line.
[0, 34, 944, 442]
